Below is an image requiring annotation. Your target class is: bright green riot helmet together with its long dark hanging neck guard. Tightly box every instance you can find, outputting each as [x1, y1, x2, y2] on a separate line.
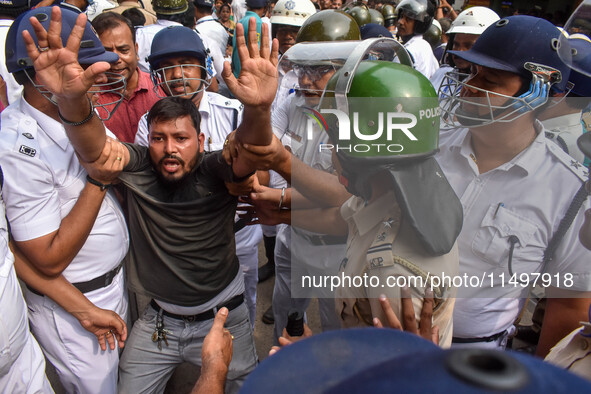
[317, 40, 463, 255]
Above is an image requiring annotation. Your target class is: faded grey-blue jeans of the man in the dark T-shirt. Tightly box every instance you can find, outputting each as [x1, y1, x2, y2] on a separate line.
[118, 303, 258, 394]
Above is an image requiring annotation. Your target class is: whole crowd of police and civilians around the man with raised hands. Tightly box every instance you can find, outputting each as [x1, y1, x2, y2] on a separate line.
[0, 0, 591, 393]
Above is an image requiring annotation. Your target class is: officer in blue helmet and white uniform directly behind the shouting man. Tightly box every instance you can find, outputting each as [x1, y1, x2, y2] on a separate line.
[135, 26, 263, 327]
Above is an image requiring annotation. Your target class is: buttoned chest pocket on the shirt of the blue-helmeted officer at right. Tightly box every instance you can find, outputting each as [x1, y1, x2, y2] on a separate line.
[472, 204, 545, 274]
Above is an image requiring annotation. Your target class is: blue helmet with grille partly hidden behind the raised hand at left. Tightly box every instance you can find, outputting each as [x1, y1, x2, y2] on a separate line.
[6, 7, 125, 120]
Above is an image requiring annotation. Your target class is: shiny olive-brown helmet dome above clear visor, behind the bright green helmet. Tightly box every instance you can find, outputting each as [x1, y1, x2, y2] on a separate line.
[296, 10, 361, 43]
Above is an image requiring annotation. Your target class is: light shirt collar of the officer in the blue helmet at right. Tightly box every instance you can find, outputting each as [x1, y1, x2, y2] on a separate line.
[448, 120, 547, 175]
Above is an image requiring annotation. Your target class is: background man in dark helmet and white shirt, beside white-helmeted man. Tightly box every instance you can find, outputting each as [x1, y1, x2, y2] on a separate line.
[396, 0, 439, 78]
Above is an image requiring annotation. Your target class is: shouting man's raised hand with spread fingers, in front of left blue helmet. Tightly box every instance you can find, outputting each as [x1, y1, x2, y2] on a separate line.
[23, 7, 110, 103]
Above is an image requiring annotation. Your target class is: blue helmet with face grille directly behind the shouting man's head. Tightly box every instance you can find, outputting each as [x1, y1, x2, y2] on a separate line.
[146, 26, 214, 97]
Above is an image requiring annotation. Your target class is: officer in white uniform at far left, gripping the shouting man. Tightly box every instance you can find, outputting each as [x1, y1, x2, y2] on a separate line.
[0, 7, 128, 393]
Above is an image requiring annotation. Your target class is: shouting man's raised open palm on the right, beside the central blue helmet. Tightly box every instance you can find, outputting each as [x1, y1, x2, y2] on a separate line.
[222, 18, 279, 106]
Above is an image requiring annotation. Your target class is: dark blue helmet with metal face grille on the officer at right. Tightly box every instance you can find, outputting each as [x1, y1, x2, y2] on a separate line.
[439, 15, 570, 127]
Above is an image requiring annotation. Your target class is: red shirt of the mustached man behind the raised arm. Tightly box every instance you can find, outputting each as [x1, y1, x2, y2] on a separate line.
[98, 69, 164, 142]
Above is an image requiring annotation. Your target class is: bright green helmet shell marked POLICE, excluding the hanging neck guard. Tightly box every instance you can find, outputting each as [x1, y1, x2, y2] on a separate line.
[319, 61, 440, 171]
